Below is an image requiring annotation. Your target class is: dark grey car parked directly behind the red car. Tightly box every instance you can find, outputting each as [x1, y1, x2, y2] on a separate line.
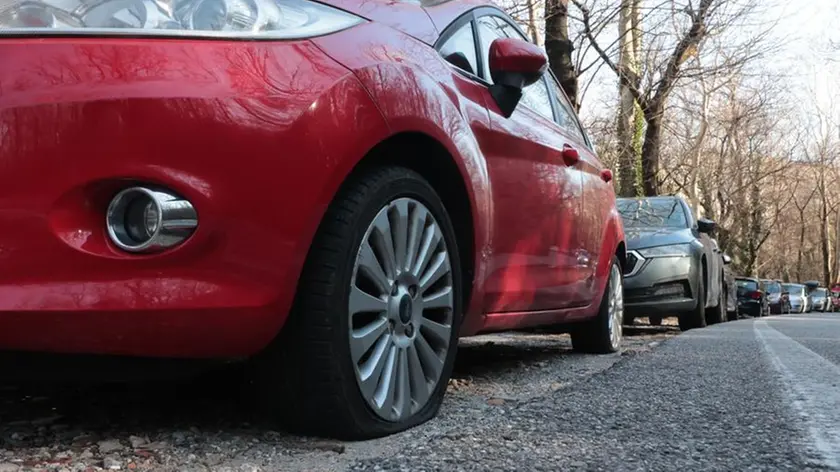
[617, 196, 727, 330]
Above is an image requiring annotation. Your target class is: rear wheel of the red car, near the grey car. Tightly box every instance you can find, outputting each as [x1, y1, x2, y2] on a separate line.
[571, 256, 624, 354]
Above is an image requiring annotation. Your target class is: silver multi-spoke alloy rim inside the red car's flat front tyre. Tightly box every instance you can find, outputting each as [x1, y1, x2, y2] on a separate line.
[348, 198, 455, 421]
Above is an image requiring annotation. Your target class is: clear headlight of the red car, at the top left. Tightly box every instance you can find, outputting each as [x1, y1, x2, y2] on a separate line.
[0, 0, 363, 39]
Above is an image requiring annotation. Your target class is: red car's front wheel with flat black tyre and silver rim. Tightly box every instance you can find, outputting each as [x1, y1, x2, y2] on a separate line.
[256, 167, 462, 439]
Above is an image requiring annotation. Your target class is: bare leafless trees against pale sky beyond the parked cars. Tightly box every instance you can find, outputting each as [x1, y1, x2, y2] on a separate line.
[500, 0, 840, 286]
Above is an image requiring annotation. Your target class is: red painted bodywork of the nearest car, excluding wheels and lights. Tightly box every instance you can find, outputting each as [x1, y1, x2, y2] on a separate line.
[0, 0, 623, 357]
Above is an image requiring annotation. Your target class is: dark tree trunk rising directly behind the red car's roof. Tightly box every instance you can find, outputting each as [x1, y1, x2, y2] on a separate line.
[544, 0, 580, 109]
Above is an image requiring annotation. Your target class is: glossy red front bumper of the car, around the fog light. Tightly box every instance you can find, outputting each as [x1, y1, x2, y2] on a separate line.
[0, 39, 385, 356]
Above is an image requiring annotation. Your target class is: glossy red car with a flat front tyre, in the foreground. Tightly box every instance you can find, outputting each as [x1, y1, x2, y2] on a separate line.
[0, 0, 625, 438]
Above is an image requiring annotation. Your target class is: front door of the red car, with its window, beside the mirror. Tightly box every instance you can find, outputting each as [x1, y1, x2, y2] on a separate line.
[476, 9, 589, 313]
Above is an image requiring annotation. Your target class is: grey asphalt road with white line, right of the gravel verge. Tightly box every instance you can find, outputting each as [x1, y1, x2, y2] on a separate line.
[348, 314, 840, 471]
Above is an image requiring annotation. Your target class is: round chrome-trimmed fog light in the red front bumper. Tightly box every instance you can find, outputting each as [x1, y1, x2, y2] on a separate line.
[106, 187, 198, 252]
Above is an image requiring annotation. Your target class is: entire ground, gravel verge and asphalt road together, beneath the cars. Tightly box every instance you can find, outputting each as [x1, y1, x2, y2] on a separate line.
[0, 314, 840, 472]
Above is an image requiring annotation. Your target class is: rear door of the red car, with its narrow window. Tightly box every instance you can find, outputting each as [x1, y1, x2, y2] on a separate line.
[546, 73, 604, 300]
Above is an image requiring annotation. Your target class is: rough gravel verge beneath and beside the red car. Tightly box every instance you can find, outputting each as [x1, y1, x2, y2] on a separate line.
[0, 318, 677, 472]
